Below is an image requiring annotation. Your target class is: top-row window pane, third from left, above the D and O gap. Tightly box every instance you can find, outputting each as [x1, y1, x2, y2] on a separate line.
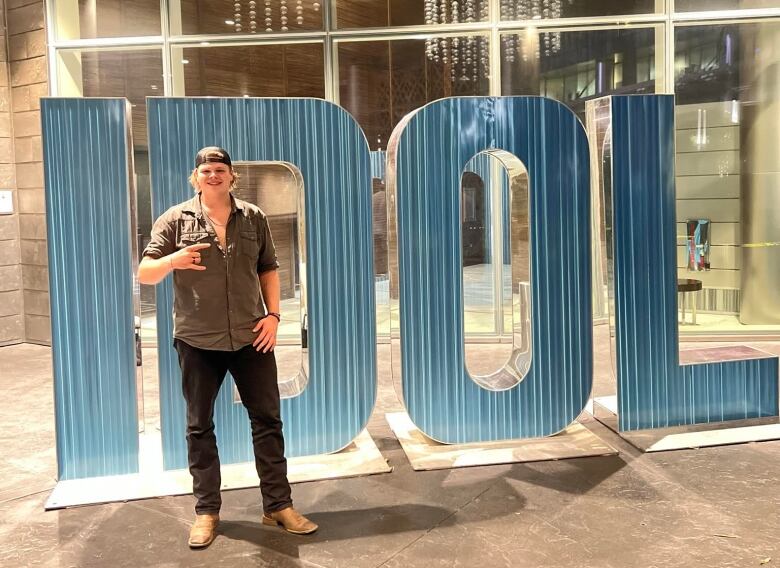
[335, 0, 489, 28]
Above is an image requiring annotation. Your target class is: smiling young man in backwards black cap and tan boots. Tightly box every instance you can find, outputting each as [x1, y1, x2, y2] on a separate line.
[138, 146, 317, 548]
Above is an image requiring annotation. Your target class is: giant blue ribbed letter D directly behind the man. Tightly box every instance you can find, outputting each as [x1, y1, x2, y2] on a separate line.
[148, 98, 376, 469]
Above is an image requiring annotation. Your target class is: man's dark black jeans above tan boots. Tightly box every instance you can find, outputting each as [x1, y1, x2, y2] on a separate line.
[174, 339, 292, 514]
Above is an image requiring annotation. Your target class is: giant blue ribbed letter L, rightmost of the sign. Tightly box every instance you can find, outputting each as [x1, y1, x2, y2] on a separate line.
[589, 95, 778, 431]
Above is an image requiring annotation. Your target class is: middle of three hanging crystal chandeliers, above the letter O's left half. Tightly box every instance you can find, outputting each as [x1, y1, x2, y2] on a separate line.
[425, 0, 488, 83]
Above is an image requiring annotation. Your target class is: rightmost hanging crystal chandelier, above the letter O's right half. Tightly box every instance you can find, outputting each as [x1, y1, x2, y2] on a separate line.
[501, 0, 561, 63]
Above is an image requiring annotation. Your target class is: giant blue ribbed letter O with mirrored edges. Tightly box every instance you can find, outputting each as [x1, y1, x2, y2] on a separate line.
[387, 97, 593, 443]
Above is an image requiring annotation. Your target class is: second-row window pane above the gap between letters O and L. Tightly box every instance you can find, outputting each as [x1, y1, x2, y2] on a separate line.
[501, 28, 663, 116]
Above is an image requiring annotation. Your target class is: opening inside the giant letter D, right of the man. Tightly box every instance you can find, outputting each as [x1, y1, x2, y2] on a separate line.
[233, 162, 308, 398]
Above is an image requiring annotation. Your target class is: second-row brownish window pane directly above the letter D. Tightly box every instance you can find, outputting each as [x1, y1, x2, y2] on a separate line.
[172, 43, 325, 98]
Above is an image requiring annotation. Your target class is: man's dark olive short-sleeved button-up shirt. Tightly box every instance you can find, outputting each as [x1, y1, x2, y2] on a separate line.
[144, 194, 279, 351]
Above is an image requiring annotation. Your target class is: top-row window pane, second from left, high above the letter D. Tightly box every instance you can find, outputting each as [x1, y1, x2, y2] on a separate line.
[171, 0, 327, 35]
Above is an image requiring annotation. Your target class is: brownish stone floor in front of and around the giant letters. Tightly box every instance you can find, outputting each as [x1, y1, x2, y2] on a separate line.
[0, 342, 780, 568]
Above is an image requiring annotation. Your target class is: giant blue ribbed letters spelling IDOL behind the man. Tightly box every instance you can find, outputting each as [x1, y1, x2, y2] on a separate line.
[42, 95, 778, 479]
